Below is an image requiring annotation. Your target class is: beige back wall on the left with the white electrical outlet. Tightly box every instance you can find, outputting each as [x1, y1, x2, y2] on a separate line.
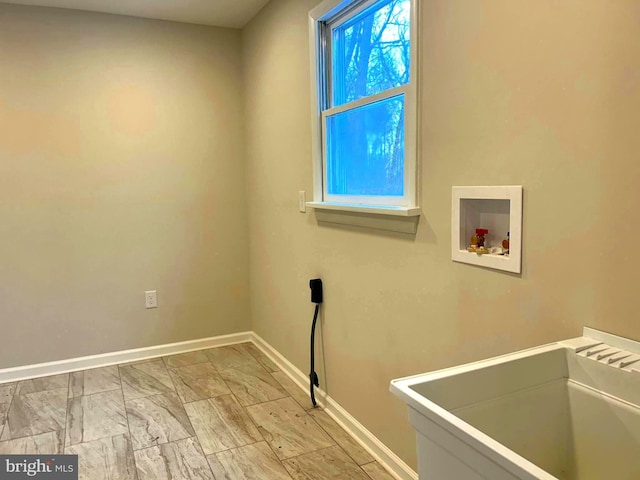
[0, 5, 250, 368]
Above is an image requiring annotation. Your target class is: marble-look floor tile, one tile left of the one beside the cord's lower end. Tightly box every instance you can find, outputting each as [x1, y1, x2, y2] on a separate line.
[220, 365, 288, 407]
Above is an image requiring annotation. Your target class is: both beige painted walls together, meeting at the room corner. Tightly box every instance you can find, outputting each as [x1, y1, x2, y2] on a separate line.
[5, 0, 640, 472]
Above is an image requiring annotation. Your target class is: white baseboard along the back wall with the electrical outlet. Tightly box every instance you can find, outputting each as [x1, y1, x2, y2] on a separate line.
[0, 332, 252, 383]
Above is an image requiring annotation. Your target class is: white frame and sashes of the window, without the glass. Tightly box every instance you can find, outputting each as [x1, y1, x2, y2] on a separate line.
[307, 0, 420, 216]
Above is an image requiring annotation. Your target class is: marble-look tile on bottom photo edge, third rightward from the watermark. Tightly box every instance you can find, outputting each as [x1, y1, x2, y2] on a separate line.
[207, 442, 291, 480]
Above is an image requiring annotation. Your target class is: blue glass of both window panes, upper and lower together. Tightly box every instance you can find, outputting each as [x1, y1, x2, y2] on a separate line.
[325, 0, 411, 197]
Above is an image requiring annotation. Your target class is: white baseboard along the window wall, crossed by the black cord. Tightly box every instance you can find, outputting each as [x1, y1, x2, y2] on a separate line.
[250, 332, 418, 480]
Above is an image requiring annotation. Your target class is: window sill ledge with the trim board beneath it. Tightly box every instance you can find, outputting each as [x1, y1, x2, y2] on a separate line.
[306, 202, 420, 235]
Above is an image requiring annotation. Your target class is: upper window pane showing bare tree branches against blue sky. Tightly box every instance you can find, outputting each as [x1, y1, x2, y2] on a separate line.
[331, 0, 411, 107]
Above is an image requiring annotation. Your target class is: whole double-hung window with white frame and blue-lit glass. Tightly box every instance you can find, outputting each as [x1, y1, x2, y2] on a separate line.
[310, 0, 419, 215]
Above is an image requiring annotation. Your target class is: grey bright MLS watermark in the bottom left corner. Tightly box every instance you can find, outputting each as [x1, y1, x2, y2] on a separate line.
[0, 455, 78, 480]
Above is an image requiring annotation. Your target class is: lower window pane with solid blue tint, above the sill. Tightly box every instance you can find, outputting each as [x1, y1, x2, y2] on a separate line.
[326, 95, 404, 196]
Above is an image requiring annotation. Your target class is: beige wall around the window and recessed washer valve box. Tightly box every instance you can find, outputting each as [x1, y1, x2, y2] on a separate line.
[243, 0, 640, 466]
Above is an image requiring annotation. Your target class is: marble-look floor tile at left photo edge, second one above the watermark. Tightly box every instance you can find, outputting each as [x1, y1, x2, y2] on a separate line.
[0, 387, 68, 440]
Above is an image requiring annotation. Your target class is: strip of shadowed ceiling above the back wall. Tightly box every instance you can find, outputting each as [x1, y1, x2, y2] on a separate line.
[0, 0, 269, 28]
